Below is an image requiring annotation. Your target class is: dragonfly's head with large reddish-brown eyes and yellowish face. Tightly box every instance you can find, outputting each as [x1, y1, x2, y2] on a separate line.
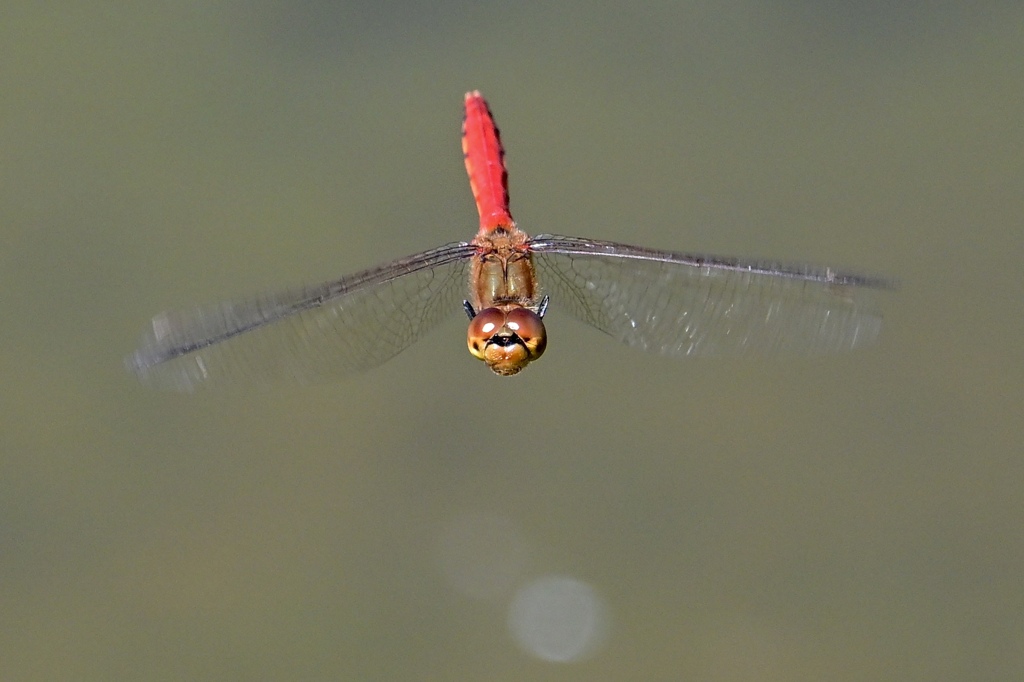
[467, 305, 548, 377]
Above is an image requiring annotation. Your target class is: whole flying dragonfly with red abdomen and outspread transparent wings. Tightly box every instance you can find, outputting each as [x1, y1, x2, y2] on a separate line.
[126, 90, 894, 390]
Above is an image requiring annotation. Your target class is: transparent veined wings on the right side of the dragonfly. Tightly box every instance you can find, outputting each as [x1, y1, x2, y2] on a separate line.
[530, 235, 894, 356]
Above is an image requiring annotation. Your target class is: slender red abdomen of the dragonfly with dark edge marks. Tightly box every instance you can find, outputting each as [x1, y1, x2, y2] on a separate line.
[462, 90, 514, 233]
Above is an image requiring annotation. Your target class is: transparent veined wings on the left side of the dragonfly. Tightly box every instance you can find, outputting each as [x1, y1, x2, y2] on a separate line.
[126, 243, 474, 390]
